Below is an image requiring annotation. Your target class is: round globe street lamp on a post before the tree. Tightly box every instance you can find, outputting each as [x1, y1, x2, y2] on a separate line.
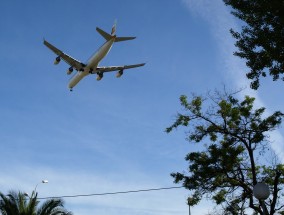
[253, 182, 270, 215]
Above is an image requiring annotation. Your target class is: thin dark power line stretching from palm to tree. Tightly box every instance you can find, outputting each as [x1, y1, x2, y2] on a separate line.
[38, 186, 183, 199]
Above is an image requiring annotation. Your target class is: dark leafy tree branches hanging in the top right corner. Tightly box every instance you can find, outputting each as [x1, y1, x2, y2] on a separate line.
[223, 0, 284, 89]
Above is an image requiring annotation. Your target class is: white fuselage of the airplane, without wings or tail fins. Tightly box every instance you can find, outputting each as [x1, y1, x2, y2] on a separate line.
[68, 36, 116, 90]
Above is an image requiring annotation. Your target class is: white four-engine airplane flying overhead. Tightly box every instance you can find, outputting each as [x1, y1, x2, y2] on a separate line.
[43, 24, 145, 91]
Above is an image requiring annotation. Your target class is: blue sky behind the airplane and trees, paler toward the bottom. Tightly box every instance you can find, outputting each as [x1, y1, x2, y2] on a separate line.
[0, 0, 284, 215]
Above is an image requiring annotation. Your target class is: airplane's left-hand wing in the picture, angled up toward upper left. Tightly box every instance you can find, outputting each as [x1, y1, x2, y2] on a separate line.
[43, 40, 85, 71]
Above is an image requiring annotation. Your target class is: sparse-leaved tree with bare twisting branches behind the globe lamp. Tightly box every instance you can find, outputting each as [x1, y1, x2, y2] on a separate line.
[166, 92, 284, 215]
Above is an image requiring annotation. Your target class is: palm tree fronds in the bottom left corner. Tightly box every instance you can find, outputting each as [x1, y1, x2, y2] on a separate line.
[0, 191, 72, 215]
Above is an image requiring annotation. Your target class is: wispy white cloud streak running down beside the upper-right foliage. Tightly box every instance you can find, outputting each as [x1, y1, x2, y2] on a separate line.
[183, 0, 284, 161]
